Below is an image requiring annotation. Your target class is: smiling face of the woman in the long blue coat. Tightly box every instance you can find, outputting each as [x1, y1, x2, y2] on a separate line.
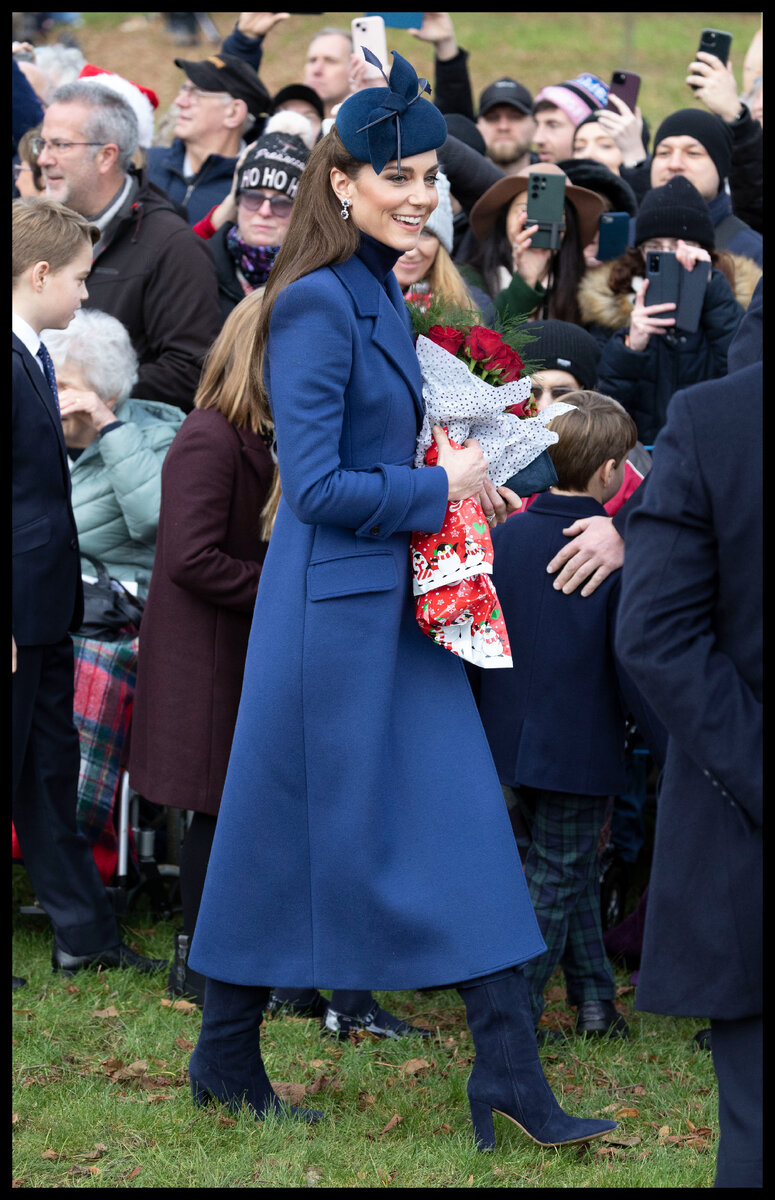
[331, 150, 439, 253]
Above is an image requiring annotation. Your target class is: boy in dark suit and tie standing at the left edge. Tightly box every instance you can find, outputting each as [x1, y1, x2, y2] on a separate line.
[12, 198, 166, 988]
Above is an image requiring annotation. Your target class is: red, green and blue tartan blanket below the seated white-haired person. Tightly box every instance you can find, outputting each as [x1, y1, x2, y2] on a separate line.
[12, 636, 139, 883]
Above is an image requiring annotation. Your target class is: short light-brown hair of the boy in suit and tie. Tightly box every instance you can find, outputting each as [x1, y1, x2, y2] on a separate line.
[11, 196, 100, 282]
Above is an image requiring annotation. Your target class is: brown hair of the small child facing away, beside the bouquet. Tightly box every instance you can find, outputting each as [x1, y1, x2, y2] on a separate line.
[547, 390, 638, 492]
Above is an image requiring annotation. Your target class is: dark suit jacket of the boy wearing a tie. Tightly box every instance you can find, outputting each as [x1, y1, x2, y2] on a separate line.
[12, 335, 83, 646]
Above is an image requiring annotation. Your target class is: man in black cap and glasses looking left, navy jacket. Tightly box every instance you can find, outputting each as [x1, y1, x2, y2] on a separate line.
[148, 54, 271, 226]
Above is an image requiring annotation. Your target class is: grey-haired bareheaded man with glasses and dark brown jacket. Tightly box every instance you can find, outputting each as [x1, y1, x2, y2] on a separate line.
[35, 79, 221, 412]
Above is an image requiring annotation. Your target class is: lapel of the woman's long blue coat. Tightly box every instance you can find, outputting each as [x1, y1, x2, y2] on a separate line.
[331, 254, 425, 419]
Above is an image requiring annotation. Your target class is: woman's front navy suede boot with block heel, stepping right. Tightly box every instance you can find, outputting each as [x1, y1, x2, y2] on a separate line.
[457, 967, 617, 1150]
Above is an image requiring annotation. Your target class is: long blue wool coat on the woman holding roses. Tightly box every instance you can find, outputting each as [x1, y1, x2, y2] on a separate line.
[190, 246, 543, 990]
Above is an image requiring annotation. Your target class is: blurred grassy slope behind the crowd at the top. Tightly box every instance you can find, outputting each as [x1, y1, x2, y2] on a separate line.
[62, 11, 762, 132]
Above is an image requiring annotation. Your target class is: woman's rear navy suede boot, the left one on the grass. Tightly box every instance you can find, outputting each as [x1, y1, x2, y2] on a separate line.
[188, 979, 323, 1122]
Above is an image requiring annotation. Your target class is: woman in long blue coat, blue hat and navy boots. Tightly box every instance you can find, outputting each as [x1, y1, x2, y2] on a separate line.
[190, 55, 612, 1146]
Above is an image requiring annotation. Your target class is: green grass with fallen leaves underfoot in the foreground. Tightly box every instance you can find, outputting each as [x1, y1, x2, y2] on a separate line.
[12, 866, 717, 1188]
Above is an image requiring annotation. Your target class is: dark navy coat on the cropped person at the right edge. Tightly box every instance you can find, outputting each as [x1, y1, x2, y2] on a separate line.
[617, 362, 763, 1020]
